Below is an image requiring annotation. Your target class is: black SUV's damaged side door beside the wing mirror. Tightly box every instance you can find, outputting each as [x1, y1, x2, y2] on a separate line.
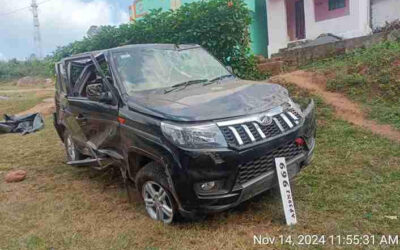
[66, 55, 119, 154]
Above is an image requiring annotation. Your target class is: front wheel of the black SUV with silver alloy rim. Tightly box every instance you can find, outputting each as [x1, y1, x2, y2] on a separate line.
[136, 162, 179, 224]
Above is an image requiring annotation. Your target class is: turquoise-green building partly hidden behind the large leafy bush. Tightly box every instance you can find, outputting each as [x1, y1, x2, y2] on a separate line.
[129, 0, 268, 56]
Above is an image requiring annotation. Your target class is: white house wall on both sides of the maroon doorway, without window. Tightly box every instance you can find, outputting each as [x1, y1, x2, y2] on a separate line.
[266, 0, 372, 55]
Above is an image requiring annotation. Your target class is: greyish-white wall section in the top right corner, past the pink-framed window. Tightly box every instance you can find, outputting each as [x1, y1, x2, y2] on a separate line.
[371, 0, 400, 29]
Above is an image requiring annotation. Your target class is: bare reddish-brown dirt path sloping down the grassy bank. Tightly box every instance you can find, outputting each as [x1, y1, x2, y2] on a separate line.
[270, 70, 400, 142]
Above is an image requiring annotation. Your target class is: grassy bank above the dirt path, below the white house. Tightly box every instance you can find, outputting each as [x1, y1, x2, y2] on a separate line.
[304, 42, 400, 129]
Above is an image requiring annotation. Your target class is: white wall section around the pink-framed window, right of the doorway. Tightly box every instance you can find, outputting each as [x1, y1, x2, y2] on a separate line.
[304, 0, 371, 39]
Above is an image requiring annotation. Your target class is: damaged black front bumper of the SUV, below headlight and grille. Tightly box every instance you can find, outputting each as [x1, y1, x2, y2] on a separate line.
[171, 100, 316, 216]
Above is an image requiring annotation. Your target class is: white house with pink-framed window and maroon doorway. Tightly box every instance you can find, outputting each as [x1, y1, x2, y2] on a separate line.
[266, 0, 400, 55]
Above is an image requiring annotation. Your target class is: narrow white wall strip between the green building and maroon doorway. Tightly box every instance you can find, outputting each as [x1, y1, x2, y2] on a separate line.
[266, 0, 289, 56]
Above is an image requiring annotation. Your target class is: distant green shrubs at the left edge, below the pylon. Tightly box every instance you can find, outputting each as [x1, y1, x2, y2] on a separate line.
[0, 59, 54, 81]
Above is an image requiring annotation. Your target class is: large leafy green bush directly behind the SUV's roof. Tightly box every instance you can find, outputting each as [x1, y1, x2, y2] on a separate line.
[54, 0, 264, 79]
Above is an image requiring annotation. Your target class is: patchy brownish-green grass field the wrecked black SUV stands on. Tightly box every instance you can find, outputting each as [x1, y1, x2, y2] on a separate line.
[0, 81, 400, 249]
